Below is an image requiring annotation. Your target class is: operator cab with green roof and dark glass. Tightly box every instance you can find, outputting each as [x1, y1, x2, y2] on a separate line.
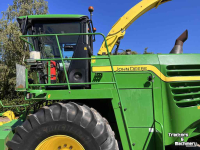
[18, 15, 94, 89]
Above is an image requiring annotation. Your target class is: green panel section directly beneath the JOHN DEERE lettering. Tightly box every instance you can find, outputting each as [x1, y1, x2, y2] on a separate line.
[116, 72, 152, 89]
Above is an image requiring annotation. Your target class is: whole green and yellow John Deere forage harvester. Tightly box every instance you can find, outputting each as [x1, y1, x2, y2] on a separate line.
[0, 0, 200, 150]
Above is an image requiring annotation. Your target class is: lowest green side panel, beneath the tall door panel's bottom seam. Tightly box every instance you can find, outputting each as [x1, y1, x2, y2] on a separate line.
[129, 128, 155, 150]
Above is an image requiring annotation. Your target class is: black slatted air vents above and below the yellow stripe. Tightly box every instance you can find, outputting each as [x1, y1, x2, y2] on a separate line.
[166, 65, 200, 107]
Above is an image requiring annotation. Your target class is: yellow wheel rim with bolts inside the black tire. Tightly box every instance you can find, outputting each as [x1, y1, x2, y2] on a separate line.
[35, 135, 85, 150]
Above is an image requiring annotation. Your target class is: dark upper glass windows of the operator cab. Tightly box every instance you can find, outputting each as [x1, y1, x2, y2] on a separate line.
[28, 22, 81, 58]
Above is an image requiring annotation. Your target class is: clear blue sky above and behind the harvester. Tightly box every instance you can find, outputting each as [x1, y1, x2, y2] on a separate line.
[0, 0, 200, 53]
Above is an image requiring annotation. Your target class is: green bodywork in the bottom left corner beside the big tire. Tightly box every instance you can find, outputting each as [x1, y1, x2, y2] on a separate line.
[0, 120, 22, 150]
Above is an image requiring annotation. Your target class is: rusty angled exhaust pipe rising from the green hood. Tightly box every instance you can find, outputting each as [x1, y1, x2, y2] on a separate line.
[170, 30, 188, 54]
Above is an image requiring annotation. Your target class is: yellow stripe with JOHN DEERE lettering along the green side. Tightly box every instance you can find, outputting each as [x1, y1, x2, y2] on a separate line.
[92, 65, 200, 82]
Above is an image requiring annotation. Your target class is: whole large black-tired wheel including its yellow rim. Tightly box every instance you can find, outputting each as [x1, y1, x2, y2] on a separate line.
[7, 102, 118, 150]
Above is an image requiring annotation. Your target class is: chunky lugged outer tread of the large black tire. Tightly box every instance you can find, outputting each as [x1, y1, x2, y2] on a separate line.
[7, 102, 118, 150]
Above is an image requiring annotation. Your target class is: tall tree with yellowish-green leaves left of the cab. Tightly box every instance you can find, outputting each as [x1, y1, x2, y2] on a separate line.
[0, 0, 48, 112]
